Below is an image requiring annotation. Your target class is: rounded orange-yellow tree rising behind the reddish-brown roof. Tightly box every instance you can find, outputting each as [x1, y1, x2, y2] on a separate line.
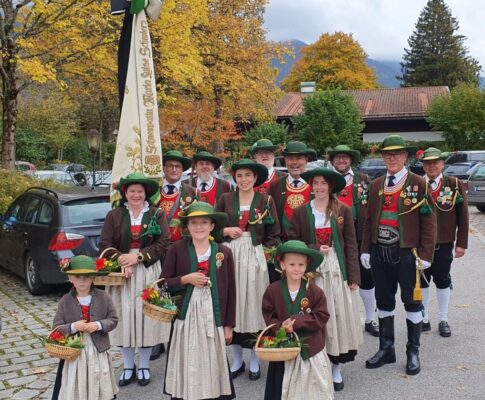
[281, 32, 377, 92]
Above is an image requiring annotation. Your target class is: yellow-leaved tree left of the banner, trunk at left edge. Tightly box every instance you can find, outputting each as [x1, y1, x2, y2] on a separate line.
[0, 0, 119, 169]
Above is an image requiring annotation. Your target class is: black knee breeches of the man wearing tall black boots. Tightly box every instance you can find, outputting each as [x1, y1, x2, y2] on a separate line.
[370, 244, 423, 312]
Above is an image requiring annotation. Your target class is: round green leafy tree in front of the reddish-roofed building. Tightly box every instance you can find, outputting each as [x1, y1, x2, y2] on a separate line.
[293, 89, 364, 154]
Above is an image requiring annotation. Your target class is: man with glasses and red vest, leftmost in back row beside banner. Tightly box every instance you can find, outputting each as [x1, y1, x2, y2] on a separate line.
[159, 150, 195, 243]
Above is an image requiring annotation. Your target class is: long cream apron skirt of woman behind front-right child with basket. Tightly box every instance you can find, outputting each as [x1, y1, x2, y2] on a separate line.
[314, 247, 364, 363]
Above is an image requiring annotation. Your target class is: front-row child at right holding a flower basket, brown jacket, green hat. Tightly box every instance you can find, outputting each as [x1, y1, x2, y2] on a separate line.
[262, 240, 333, 400]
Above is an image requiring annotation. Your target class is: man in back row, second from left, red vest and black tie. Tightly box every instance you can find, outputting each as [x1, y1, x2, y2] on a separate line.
[184, 151, 231, 206]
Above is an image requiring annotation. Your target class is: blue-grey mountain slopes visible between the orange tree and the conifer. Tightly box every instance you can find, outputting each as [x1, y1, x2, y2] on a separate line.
[271, 39, 485, 88]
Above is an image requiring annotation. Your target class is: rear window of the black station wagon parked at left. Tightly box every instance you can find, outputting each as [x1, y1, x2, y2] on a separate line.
[62, 197, 111, 226]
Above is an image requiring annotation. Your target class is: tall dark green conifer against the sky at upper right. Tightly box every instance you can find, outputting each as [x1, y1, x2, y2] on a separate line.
[397, 0, 481, 87]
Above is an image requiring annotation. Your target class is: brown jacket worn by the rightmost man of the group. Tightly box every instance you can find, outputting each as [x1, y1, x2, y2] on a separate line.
[436, 175, 469, 249]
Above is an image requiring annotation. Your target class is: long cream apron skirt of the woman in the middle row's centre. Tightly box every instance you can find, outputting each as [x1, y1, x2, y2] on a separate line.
[224, 232, 269, 333]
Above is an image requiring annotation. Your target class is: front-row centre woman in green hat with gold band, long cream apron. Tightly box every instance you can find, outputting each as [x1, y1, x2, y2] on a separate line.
[160, 202, 236, 400]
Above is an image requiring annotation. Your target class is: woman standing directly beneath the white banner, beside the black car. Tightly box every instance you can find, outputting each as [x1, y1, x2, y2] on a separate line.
[99, 172, 170, 386]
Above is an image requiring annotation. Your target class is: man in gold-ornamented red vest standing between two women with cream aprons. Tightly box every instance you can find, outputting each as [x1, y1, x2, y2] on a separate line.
[269, 141, 311, 241]
